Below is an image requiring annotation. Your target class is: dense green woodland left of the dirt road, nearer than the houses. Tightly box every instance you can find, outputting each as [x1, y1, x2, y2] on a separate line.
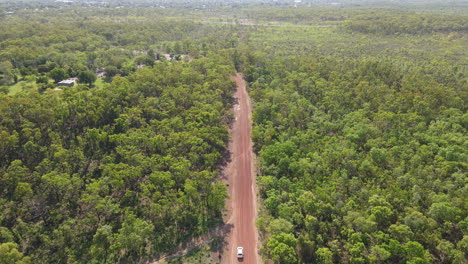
[0, 54, 234, 263]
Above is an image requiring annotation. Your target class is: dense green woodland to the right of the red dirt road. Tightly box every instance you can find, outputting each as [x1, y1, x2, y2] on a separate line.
[249, 6, 468, 263]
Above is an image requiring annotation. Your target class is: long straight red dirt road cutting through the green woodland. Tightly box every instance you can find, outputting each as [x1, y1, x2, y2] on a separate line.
[221, 74, 261, 264]
